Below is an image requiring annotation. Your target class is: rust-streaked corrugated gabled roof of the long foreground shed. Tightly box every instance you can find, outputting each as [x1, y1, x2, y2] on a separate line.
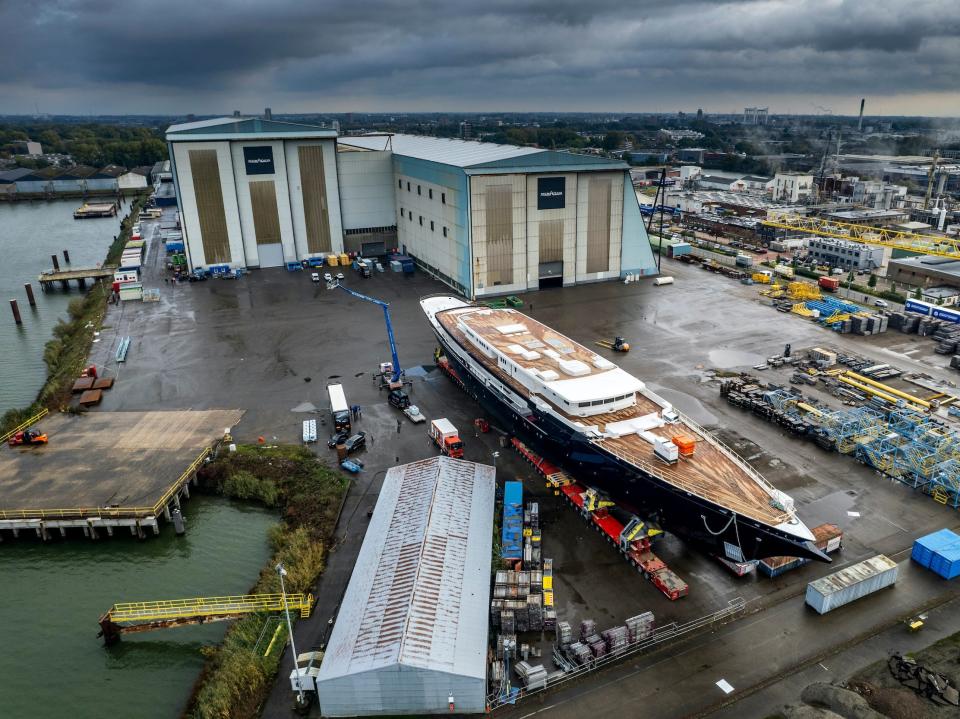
[318, 457, 495, 681]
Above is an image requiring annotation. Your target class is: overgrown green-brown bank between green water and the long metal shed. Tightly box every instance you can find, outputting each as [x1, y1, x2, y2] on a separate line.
[184, 445, 349, 719]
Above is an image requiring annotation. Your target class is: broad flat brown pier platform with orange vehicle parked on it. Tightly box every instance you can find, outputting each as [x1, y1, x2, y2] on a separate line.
[0, 410, 243, 541]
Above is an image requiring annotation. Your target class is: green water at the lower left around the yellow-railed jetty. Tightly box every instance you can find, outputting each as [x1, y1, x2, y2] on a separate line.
[0, 495, 276, 719]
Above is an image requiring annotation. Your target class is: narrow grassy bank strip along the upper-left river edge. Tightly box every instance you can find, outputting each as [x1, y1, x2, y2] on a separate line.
[0, 195, 146, 434]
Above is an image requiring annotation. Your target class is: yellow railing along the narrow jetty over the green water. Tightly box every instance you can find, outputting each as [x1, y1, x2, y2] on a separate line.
[106, 594, 313, 623]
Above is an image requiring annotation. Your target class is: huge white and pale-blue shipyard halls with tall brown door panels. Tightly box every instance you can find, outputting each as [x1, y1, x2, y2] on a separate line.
[167, 118, 656, 299]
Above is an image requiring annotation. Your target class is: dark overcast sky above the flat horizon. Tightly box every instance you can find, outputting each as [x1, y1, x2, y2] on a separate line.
[0, 0, 960, 116]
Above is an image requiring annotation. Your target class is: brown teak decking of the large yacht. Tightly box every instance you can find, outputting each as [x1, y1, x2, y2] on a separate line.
[436, 308, 791, 530]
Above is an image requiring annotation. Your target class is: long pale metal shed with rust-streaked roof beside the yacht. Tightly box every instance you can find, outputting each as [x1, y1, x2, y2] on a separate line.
[316, 457, 495, 716]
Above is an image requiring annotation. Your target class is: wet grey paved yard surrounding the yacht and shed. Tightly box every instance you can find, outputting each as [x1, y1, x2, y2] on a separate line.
[84, 236, 958, 715]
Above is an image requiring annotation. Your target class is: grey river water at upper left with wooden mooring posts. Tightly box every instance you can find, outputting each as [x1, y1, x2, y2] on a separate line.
[0, 200, 124, 414]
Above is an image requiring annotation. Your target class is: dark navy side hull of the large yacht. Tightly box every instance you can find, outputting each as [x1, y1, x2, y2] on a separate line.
[438, 336, 830, 562]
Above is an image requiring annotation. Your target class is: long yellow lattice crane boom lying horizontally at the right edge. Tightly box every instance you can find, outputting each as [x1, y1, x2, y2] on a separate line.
[763, 215, 960, 260]
